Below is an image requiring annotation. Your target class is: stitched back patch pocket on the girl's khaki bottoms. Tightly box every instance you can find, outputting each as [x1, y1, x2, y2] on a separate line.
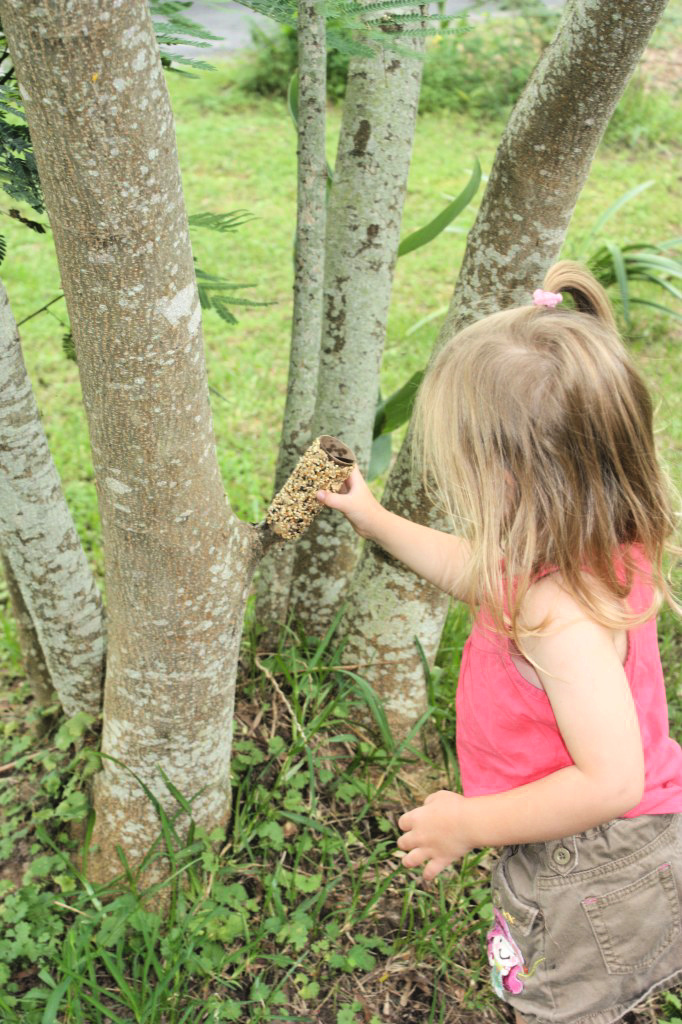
[583, 864, 682, 974]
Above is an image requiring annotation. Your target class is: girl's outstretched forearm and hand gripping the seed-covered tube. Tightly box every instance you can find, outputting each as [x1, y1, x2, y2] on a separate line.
[317, 469, 470, 600]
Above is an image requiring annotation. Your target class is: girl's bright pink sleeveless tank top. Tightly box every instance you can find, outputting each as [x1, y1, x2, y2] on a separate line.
[457, 557, 682, 818]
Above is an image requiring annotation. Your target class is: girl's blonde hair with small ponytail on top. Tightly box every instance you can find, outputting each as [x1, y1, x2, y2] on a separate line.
[415, 260, 680, 644]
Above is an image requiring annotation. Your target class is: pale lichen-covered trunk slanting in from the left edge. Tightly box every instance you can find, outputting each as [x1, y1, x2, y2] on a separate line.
[0, 283, 104, 715]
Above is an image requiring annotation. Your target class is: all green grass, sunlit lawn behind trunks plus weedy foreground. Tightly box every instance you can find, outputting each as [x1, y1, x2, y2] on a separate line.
[0, 0, 682, 1024]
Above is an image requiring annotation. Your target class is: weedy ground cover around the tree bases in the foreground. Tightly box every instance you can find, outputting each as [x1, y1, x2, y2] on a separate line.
[0, 630, 497, 1024]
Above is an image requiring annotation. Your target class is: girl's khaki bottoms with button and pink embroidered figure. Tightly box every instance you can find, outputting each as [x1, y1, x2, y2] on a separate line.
[487, 814, 682, 1024]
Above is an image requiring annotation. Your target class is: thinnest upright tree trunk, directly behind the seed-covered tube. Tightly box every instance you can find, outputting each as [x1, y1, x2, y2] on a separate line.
[256, 0, 327, 638]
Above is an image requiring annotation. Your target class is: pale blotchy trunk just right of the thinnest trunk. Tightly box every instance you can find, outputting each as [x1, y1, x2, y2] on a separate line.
[291, 28, 422, 634]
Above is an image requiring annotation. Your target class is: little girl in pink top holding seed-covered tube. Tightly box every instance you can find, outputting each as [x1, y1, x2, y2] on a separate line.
[317, 261, 682, 1024]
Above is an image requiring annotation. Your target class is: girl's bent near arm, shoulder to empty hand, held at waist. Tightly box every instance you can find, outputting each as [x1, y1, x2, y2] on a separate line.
[398, 577, 644, 881]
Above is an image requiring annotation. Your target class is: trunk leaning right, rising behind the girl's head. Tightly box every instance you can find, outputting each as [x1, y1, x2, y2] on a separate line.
[340, 0, 666, 735]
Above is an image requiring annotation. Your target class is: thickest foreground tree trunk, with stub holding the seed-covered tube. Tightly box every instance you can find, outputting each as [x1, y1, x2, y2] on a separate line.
[0, 0, 259, 879]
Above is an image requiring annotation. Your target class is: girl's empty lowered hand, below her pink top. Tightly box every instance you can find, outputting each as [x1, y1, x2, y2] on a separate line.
[398, 790, 474, 882]
